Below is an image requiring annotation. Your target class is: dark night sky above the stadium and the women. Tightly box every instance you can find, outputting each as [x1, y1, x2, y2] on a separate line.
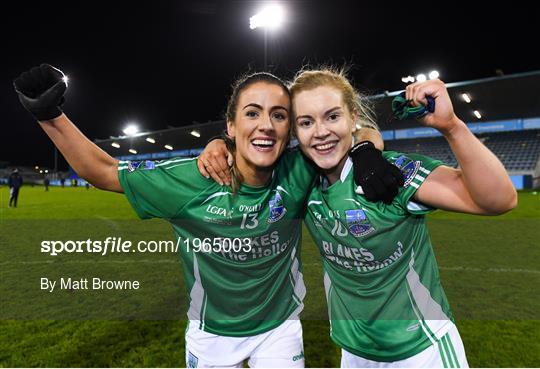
[0, 0, 540, 169]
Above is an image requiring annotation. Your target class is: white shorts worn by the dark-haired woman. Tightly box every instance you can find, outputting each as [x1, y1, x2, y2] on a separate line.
[186, 319, 304, 368]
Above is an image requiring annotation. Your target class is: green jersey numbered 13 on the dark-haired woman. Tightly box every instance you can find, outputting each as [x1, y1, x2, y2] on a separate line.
[118, 151, 316, 337]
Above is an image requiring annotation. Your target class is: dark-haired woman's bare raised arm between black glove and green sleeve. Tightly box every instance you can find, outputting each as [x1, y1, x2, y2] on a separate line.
[39, 114, 123, 193]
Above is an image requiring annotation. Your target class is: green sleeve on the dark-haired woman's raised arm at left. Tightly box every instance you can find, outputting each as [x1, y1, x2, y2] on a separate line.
[118, 158, 211, 219]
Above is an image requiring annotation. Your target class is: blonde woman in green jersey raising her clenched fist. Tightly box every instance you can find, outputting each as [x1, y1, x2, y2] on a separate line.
[198, 68, 517, 368]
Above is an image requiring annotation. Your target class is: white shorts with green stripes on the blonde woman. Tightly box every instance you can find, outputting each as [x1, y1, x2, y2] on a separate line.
[341, 324, 469, 368]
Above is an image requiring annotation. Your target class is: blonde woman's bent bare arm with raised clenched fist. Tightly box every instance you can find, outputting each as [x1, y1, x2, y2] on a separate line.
[406, 80, 517, 215]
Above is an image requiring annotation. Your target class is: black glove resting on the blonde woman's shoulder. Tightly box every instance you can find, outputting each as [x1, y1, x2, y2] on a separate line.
[349, 141, 404, 204]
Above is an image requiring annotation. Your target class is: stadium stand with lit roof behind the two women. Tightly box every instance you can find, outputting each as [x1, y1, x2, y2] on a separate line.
[95, 71, 540, 188]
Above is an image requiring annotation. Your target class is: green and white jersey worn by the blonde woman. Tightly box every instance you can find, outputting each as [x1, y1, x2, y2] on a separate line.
[306, 151, 453, 361]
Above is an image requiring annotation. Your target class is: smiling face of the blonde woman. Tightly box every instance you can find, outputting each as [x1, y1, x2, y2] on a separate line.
[293, 86, 356, 183]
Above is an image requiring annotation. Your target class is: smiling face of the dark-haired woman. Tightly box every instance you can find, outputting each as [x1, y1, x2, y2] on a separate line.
[227, 82, 290, 184]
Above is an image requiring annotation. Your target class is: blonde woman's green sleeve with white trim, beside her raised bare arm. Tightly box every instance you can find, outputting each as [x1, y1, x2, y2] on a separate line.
[383, 151, 444, 215]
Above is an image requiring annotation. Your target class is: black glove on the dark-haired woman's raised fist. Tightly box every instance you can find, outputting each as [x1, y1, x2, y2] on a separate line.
[13, 64, 67, 120]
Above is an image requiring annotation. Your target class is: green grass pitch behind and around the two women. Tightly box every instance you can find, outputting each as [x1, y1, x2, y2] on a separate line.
[0, 187, 540, 367]
